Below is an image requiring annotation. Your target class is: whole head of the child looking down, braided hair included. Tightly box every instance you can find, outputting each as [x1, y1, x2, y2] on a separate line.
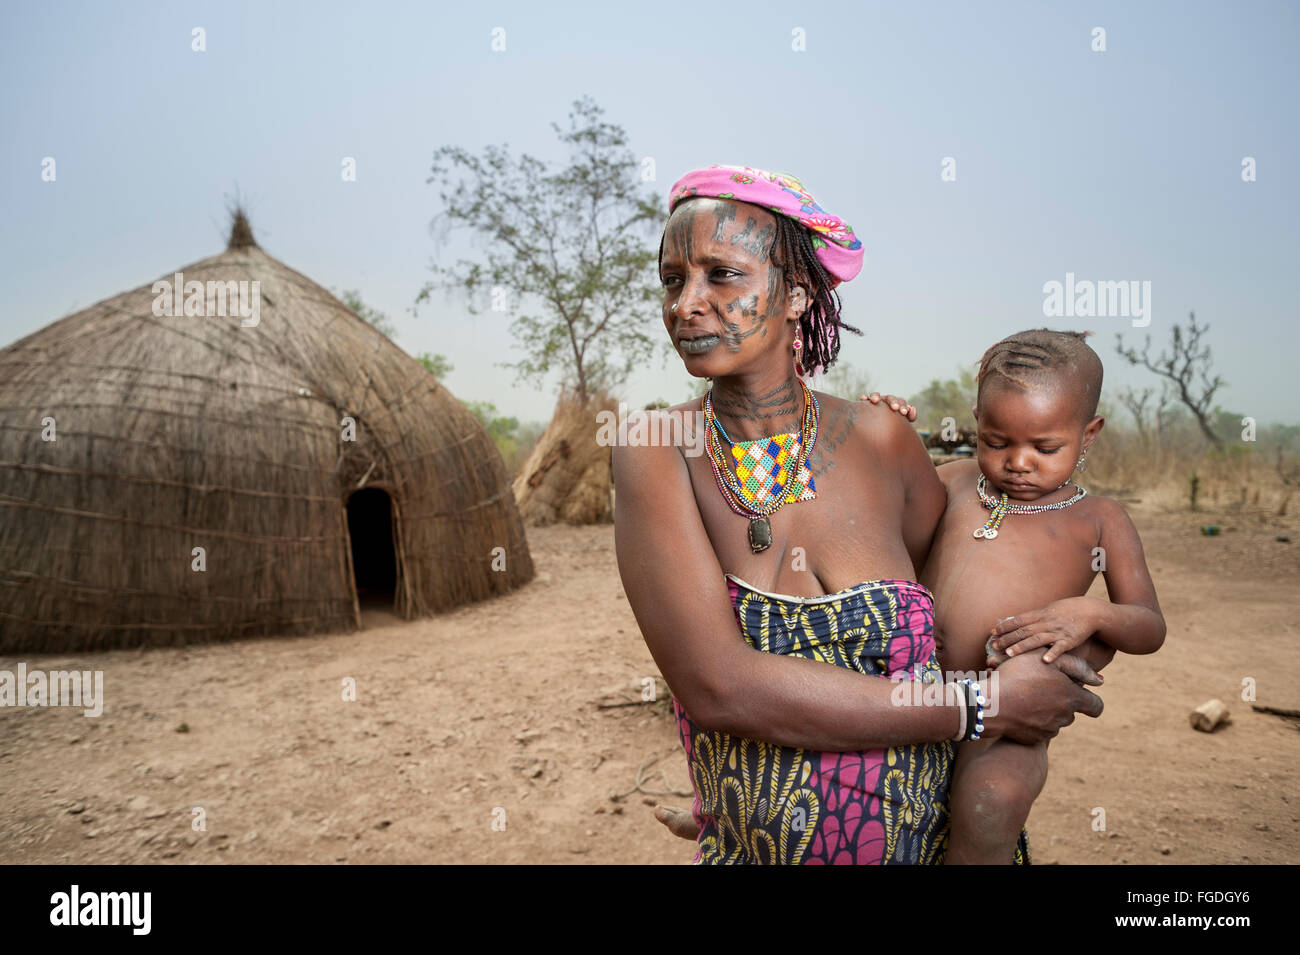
[975, 329, 1105, 502]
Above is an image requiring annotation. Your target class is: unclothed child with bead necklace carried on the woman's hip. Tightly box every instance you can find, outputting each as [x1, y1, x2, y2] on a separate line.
[920, 329, 1165, 864]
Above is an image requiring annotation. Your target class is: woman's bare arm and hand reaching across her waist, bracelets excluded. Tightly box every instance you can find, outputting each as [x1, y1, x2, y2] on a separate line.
[614, 436, 1101, 752]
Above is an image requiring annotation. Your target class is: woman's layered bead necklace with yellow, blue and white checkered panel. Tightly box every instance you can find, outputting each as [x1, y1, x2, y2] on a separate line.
[702, 381, 818, 554]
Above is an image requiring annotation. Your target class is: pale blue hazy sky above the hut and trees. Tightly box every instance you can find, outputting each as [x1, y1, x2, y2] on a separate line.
[0, 0, 1300, 421]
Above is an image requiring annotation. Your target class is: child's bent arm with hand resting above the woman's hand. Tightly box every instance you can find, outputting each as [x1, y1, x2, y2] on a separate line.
[992, 500, 1165, 663]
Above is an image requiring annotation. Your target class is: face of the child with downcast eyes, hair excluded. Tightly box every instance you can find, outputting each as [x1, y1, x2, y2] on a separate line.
[975, 383, 1105, 503]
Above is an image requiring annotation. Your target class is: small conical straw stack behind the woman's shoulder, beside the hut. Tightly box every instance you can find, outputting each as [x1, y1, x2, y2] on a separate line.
[515, 392, 618, 525]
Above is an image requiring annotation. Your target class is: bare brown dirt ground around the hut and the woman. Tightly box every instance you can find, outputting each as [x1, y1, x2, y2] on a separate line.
[0, 504, 1300, 864]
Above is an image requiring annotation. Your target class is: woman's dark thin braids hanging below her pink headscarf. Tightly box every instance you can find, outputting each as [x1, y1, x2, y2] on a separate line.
[659, 196, 862, 374]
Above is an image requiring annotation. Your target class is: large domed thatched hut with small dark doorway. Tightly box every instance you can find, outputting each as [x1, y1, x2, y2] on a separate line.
[0, 214, 533, 652]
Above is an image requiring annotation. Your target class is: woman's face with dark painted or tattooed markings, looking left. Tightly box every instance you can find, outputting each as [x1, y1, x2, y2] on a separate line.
[659, 199, 807, 378]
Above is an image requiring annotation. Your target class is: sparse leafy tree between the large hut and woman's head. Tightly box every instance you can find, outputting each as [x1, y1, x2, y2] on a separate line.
[416, 97, 666, 401]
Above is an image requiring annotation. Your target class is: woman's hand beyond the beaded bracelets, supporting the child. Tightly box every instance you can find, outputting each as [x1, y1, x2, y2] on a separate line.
[984, 655, 1102, 745]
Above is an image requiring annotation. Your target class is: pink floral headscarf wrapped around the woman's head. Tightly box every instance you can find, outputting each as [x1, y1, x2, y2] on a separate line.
[668, 166, 863, 287]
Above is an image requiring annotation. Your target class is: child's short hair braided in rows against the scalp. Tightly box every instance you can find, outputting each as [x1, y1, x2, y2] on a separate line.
[975, 329, 1102, 421]
